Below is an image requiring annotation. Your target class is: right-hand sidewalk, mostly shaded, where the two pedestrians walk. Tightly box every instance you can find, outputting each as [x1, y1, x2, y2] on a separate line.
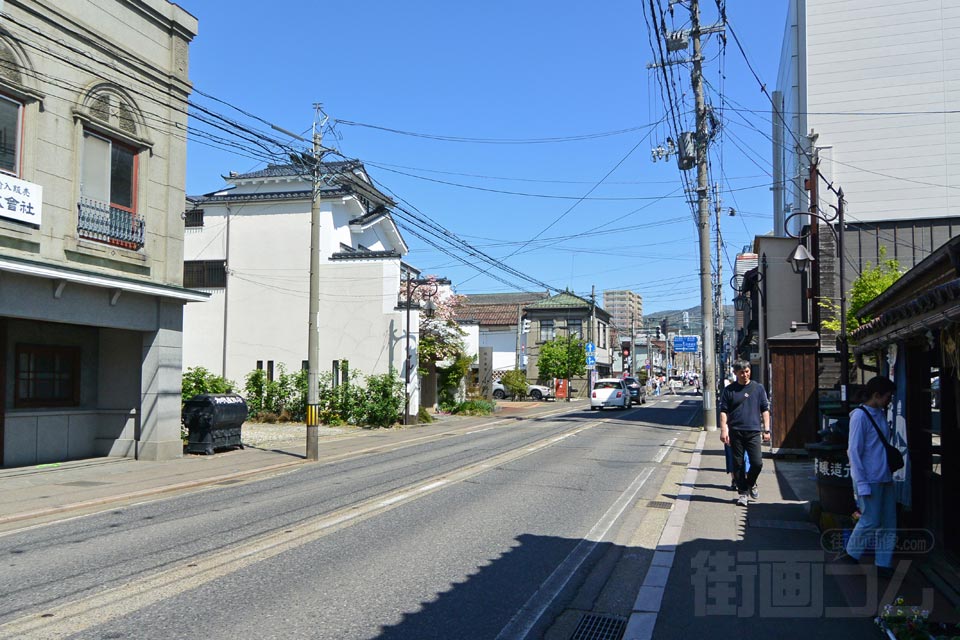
[624, 432, 956, 640]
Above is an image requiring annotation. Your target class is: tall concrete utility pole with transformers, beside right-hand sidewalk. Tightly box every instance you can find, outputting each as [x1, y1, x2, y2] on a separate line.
[690, 0, 717, 431]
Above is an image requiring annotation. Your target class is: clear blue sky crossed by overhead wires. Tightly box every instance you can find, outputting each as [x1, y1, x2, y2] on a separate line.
[179, 0, 786, 313]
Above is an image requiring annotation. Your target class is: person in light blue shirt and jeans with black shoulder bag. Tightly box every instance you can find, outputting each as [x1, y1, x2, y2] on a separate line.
[841, 376, 897, 578]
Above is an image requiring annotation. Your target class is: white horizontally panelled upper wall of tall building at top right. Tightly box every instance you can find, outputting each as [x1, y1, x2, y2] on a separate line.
[778, 0, 960, 222]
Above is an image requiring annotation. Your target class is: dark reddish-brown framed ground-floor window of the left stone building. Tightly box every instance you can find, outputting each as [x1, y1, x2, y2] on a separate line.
[14, 344, 80, 407]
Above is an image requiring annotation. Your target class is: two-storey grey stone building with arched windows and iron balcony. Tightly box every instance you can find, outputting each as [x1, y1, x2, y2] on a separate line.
[0, 0, 198, 467]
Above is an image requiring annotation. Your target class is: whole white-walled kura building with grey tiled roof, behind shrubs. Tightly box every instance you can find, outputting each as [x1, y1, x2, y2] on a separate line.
[183, 161, 420, 414]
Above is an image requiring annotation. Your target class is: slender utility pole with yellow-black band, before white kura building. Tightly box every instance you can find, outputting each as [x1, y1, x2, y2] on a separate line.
[307, 104, 327, 461]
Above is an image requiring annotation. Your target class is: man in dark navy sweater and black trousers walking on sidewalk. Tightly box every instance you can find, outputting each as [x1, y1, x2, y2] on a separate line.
[720, 360, 770, 507]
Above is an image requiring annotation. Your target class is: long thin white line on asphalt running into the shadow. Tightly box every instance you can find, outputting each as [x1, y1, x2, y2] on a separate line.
[496, 469, 653, 640]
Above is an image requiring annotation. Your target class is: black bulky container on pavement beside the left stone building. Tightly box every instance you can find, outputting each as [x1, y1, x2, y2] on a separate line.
[181, 393, 247, 454]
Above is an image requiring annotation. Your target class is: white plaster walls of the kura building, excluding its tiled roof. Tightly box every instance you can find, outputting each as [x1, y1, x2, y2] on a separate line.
[184, 192, 419, 409]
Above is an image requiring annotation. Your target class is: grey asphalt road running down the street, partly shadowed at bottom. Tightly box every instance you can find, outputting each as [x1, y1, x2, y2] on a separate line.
[0, 396, 699, 640]
